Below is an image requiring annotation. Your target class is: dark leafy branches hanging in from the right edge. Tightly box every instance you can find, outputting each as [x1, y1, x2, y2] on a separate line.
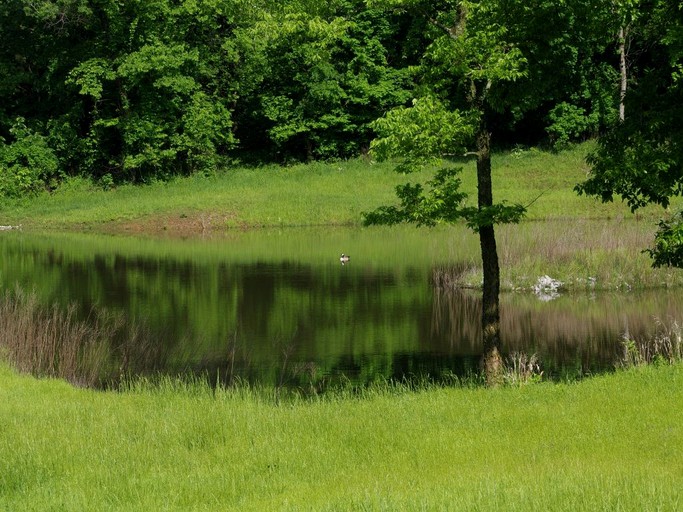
[577, 0, 683, 268]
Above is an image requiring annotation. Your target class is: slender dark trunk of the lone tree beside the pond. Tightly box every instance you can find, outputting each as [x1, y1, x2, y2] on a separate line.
[477, 128, 503, 385]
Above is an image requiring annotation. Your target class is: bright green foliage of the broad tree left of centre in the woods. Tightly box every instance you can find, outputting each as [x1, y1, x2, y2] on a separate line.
[67, 6, 235, 180]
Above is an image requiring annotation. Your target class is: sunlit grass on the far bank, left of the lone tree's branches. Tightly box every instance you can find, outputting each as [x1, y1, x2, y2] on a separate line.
[0, 160, 402, 230]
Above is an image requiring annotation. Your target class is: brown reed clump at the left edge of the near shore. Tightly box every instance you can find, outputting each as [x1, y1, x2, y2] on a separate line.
[0, 287, 160, 387]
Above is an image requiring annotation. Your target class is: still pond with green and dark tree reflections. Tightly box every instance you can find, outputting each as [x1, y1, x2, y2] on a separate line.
[0, 227, 683, 386]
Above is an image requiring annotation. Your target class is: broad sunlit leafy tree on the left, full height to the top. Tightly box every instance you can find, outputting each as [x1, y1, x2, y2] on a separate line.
[67, 0, 244, 181]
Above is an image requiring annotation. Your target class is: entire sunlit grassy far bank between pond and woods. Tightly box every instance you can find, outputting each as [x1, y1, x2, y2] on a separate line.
[0, 143, 672, 229]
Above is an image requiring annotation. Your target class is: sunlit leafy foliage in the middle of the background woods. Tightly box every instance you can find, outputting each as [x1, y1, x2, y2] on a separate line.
[251, 1, 408, 159]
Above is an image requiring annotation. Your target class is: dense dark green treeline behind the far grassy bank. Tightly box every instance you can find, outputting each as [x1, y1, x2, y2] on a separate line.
[0, 0, 672, 196]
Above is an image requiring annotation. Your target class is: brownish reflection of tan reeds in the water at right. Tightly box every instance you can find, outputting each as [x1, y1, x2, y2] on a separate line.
[432, 266, 678, 376]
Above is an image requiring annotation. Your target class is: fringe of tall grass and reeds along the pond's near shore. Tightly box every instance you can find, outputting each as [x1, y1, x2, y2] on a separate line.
[0, 288, 683, 392]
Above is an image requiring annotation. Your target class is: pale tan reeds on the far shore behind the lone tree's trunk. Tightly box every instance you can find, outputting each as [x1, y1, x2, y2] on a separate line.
[434, 219, 683, 292]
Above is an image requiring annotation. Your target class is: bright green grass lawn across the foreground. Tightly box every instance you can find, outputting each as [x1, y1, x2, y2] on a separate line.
[0, 364, 683, 511]
